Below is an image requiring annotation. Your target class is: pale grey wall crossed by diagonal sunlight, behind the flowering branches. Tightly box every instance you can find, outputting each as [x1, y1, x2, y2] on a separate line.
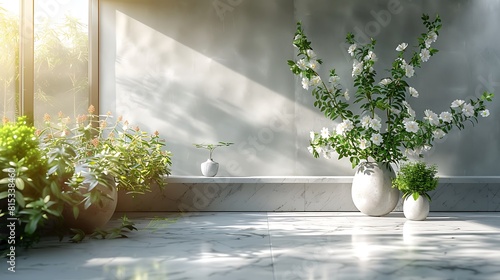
[100, 0, 500, 176]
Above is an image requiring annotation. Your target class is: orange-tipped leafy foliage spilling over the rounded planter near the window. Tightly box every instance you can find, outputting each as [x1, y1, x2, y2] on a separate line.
[41, 106, 171, 199]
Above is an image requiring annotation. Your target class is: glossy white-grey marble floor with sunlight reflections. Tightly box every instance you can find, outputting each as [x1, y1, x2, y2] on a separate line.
[0, 212, 500, 280]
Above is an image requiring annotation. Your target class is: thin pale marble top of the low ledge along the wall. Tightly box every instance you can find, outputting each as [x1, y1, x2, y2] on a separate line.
[165, 175, 500, 184]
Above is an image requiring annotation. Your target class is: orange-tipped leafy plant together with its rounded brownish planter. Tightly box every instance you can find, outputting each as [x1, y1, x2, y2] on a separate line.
[40, 106, 171, 232]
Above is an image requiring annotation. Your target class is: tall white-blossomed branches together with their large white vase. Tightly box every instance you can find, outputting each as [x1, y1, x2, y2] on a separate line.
[288, 14, 493, 216]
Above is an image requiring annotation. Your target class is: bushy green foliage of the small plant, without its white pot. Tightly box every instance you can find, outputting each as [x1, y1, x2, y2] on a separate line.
[392, 161, 438, 200]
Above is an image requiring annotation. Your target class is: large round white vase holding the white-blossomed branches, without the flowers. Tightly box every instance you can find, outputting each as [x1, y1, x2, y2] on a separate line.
[351, 162, 399, 216]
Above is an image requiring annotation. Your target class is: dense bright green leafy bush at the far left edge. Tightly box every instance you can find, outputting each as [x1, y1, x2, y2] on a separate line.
[0, 117, 75, 247]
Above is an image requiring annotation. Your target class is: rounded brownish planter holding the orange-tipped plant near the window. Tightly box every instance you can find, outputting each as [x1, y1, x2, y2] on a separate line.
[62, 176, 118, 233]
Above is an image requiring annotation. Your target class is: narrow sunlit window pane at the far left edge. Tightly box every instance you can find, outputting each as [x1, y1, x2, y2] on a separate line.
[0, 0, 19, 120]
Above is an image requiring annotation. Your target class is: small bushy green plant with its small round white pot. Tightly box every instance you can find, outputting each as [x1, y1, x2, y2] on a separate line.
[392, 161, 438, 221]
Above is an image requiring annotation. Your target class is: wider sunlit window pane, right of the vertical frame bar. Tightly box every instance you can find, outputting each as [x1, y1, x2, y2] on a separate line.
[34, 0, 89, 124]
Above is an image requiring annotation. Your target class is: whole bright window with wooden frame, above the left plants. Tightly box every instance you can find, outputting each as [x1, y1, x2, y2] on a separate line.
[0, 0, 98, 124]
